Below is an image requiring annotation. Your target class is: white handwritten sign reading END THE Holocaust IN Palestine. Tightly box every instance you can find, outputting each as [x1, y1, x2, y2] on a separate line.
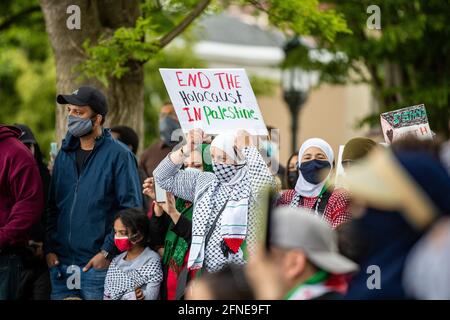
[159, 69, 268, 135]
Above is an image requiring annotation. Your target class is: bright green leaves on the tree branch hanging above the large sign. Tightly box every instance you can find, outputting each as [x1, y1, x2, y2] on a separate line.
[81, 0, 350, 84]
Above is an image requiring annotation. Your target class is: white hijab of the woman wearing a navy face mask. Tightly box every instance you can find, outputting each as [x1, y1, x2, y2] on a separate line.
[295, 138, 334, 198]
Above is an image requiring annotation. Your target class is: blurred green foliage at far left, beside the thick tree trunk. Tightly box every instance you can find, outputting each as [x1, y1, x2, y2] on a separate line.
[0, 0, 56, 156]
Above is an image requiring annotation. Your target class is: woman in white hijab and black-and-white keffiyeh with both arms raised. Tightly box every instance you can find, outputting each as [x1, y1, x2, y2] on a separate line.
[151, 129, 274, 272]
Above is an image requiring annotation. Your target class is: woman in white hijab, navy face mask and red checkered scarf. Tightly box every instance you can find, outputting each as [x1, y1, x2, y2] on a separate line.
[277, 138, 351, 229]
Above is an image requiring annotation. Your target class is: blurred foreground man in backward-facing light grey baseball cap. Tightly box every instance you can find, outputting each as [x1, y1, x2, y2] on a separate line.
[247, 207, 358, 300]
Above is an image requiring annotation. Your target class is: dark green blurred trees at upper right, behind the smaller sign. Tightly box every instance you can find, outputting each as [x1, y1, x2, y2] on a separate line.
[292, 0, 450, 134]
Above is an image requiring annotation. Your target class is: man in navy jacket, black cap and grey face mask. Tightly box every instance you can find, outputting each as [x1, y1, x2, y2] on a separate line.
[44, 86, 142, 300]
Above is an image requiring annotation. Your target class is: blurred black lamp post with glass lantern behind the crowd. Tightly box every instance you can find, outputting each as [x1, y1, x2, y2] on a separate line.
[282, 37, 311, 152]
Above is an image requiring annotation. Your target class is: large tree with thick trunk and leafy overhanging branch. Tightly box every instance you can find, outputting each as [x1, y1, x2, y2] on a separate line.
[40, 0, 348, 146]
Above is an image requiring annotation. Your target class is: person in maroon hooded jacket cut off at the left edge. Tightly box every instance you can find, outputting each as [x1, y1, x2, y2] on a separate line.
[0, 125, 44, 300]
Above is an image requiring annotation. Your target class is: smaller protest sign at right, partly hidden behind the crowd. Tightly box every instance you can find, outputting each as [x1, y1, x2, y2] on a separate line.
[380, 104, 433, 144]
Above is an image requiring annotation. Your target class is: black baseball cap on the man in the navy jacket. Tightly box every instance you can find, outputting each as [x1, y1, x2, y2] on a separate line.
[56, 86, 108, 117]
